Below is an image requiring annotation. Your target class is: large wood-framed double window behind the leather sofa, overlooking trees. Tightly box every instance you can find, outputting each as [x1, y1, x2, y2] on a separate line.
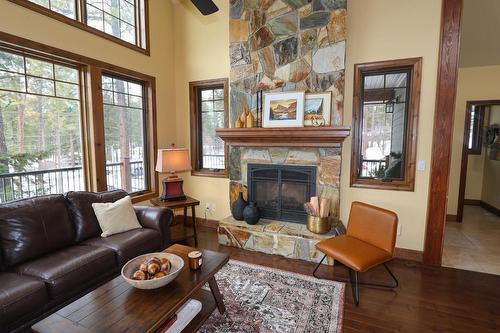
[0, 33, 158, 202]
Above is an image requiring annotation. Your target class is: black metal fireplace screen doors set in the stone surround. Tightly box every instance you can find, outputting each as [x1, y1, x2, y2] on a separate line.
[248, 164, 316, 224]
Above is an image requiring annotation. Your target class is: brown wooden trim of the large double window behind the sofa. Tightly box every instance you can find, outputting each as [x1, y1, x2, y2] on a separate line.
[0, 31, 159, 203]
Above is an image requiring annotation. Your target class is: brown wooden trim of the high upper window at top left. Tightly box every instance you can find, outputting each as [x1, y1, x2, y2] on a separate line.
[8, 0, 150, 56]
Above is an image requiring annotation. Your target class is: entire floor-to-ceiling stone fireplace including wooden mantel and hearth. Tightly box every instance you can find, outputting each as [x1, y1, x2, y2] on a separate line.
[221, 0, 349, 261]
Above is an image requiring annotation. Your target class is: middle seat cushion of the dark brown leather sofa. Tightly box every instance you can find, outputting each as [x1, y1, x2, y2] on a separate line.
[14, 245, 118, 299]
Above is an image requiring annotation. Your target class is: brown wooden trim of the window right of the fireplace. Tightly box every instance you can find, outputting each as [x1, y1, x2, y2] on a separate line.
[350, 58, 422, 191]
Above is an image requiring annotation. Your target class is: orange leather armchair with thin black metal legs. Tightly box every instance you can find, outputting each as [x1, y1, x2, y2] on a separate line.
[313, 201, 399, 305]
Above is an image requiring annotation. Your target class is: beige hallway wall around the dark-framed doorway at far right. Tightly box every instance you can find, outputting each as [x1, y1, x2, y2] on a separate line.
[447, 66, 500, 215]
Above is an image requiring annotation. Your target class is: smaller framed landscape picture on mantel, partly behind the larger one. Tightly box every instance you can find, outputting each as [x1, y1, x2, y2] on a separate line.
[304, 91, 332, 126]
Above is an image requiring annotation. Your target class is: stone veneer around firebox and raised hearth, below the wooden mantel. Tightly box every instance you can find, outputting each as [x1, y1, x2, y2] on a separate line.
[218, 146, 341, 264]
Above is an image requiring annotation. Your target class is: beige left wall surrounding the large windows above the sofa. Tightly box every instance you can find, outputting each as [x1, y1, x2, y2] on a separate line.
[0, 0, 176, 195]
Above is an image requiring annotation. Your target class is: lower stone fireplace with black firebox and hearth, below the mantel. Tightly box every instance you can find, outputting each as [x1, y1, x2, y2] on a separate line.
[218, 146, 341, 262]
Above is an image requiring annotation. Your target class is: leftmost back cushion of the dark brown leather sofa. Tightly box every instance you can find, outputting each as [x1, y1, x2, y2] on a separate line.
[0, 195, 74, 266]
